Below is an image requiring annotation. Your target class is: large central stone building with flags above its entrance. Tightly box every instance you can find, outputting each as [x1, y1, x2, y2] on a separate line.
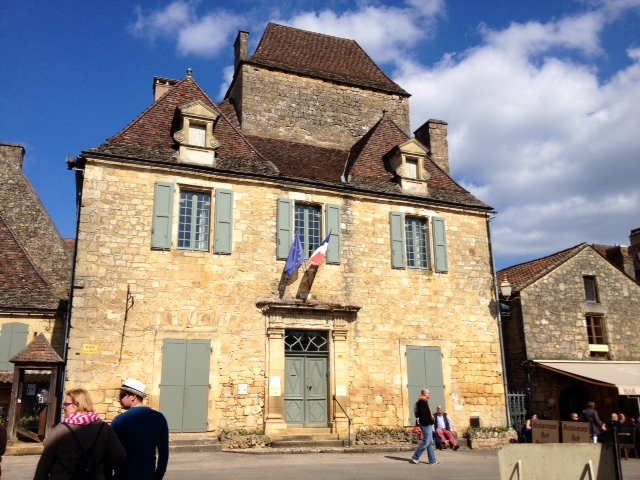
[67, 24, 506, 435]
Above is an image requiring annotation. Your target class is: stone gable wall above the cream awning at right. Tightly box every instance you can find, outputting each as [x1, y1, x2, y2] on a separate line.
[520, 248, 640, 360]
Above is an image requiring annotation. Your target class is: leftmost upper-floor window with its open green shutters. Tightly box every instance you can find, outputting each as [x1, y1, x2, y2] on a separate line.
[151, 182, 233, 254]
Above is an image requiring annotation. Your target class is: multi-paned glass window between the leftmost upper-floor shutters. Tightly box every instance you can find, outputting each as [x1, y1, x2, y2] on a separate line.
[178, 192, 211, 251]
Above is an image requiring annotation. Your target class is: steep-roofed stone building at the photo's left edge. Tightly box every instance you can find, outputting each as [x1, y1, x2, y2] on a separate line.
[0, 143, 72, 431]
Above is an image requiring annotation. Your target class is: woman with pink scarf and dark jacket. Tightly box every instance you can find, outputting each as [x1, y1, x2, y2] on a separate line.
[33, 388, 127, 480]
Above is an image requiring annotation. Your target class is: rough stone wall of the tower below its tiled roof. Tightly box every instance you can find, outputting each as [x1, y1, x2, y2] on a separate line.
[229, 64, 410, 148]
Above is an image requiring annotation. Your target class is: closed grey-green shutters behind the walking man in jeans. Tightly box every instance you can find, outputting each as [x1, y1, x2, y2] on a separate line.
[407, 346, 446, 424]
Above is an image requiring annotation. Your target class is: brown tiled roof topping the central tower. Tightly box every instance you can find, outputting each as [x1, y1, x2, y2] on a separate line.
[245, 23, 409, 96]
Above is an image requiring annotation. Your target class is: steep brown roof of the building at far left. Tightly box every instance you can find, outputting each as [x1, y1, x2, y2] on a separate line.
[0, 143, 71, 311]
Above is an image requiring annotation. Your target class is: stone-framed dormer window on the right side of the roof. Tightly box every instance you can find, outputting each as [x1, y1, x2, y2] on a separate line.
[386, 138, 429, 195]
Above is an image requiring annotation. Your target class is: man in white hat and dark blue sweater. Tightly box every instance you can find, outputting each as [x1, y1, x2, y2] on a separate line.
[111, 378, 169, 480]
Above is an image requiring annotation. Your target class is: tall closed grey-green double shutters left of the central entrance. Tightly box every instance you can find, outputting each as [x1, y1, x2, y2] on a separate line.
[160, 340, 211, 432]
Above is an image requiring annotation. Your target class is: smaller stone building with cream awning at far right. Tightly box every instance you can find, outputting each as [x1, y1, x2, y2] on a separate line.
[498, 243, 640, 426]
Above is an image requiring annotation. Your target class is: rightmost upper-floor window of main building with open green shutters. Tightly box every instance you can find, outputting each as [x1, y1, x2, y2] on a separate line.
[390, 212, 449, 273]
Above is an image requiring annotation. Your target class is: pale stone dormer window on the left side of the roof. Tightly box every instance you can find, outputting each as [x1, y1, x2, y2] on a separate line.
[173, 100, 220, 166]
